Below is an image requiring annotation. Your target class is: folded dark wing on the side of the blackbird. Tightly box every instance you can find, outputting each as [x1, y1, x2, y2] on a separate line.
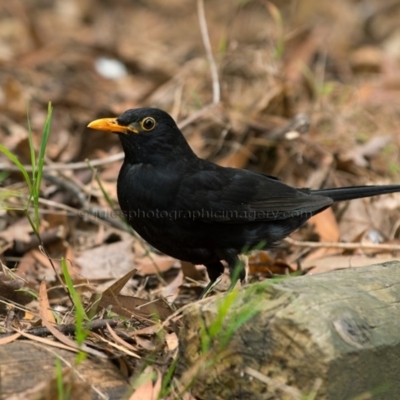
[175, 168, 333, 223]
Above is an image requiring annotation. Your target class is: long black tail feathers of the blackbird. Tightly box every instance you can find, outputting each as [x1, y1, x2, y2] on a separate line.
[310, 185, 400, 201]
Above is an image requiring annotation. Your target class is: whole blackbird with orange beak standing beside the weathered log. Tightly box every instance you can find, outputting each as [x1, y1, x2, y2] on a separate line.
[88, 108, 400, 290]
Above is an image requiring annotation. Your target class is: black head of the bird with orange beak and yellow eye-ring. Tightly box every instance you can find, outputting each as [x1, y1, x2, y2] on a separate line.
[88, 108, 193, 163]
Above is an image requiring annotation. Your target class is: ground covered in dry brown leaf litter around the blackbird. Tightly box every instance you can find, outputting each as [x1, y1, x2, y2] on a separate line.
[0, 0, 400, 399]
